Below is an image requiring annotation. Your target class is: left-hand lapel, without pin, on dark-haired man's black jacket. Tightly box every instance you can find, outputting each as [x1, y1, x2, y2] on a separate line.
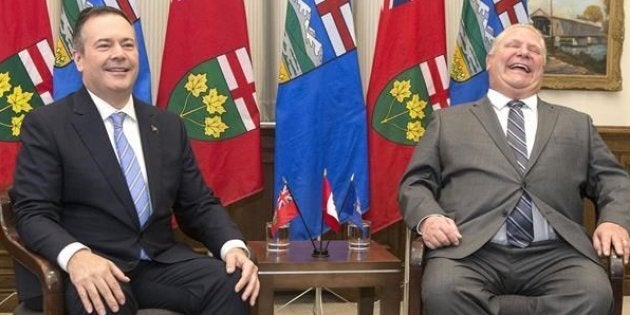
[72, 88, 138, 224]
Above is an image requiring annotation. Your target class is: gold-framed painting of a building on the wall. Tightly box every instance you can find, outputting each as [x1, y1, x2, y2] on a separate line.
[528, 0, 624, 91]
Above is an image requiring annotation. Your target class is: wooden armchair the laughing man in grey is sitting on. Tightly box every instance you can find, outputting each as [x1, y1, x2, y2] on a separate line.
[405, 229, 625, 315]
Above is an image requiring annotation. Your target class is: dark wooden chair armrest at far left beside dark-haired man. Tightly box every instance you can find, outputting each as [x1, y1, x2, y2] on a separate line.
[0, 196, 64, 315]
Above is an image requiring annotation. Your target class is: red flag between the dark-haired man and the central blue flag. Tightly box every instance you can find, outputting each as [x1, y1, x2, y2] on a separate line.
[157, 0, 263, 205]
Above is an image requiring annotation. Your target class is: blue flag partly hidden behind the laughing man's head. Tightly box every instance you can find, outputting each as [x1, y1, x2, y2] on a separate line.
[451, 0, 529, 105]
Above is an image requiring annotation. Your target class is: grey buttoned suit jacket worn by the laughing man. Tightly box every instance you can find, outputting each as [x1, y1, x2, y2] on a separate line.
[399, 98, 630, 262]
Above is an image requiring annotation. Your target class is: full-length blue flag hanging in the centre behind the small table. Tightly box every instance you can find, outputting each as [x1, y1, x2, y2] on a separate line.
[275, 0, 368, 239]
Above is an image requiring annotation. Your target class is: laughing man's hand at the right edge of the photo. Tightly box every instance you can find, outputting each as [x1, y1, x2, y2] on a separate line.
[593, 222, 630, 265]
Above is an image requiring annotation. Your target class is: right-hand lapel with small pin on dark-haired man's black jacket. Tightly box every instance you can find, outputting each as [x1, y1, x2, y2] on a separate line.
[134, 98, 162, 226]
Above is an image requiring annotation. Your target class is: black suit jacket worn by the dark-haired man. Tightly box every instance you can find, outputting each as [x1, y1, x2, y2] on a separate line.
[10, 88, 243, 298]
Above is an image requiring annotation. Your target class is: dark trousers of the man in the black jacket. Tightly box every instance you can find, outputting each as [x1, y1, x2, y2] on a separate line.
[65, 256, 249, 314]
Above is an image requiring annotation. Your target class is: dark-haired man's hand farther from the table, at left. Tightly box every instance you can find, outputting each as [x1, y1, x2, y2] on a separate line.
[68, 249, 129, 315]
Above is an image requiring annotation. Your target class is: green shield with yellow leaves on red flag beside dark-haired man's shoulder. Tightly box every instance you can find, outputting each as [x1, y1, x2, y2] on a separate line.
[168, 47, 258, 141]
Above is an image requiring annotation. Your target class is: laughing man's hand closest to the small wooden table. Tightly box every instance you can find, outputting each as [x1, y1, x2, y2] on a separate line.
[420, 216, 462, 249]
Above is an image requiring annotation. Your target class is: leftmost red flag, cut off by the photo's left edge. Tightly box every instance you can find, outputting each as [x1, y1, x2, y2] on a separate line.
[0, 0, 54, 191]
